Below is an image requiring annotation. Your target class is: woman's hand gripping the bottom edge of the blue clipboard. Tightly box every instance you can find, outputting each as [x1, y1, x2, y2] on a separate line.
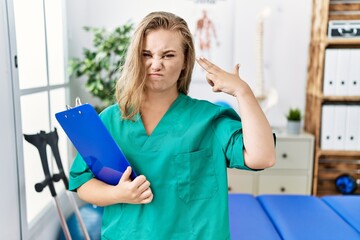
[114, 167, 153, 204]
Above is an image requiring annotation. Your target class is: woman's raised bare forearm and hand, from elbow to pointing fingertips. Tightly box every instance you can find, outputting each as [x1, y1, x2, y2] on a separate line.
[196, 58, 275, 169]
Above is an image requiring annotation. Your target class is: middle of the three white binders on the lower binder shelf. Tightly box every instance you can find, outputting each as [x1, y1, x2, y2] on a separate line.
[333, 105, 346, 150]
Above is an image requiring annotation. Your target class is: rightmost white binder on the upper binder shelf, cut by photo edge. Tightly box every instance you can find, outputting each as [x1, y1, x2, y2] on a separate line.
[347, 49, 360, 96]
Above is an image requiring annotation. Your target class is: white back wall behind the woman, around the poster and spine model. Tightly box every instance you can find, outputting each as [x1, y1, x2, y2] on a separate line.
[67, 0, 312, 127]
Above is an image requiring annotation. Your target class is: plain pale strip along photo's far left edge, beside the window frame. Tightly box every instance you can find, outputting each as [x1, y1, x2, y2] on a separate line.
[0, 0, 21, 239]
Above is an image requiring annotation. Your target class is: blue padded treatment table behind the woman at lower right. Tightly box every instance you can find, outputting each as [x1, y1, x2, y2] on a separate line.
[229, 194, 360, 240]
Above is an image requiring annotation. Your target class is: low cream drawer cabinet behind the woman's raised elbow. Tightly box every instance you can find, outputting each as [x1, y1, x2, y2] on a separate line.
[228, 133, 314, 195]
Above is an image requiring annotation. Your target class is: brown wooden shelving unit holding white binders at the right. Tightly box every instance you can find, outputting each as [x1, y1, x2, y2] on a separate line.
[305, 0, 360, 196]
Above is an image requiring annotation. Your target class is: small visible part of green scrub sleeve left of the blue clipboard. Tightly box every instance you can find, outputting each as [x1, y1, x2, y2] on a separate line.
[69, 153, 94, 191]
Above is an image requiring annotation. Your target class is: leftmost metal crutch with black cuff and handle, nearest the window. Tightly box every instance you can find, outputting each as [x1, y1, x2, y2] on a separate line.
[24, 131, 71, 240]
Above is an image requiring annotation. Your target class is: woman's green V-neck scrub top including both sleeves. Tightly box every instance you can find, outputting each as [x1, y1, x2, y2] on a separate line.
[69, 94, 253, 240]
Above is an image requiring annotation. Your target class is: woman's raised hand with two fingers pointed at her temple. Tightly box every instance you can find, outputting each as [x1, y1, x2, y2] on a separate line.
[196, 57, 250, 97]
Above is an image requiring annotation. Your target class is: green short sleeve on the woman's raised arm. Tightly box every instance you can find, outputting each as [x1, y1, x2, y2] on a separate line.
[212, 108, 251, 170]
